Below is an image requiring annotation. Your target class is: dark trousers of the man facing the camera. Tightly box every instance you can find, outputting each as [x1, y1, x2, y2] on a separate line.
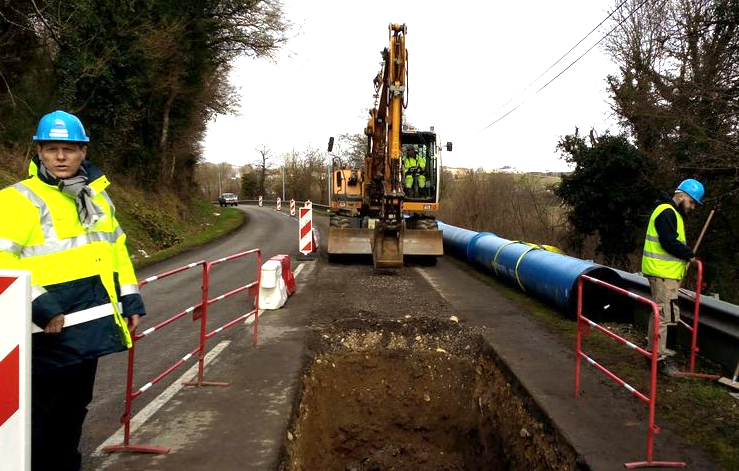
[31, 359, 97, 471]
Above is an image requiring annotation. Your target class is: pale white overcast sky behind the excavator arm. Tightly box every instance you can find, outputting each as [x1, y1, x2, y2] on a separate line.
[204, 0, 617, 171]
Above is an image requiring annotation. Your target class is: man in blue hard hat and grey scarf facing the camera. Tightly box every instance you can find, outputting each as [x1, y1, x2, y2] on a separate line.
[0, 111, 144, 471]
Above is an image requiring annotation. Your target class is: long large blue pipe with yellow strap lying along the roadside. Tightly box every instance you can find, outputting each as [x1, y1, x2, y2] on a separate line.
[439, 222, 620, 314]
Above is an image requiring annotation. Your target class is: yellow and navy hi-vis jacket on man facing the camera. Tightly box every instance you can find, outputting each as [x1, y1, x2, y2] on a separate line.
[0, 158, 145, 368]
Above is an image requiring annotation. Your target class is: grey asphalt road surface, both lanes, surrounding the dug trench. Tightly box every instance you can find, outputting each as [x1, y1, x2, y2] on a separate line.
[83, 207, 718, 471]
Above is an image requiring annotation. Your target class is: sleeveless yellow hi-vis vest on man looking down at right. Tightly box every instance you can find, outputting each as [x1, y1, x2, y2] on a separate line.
[642, 203, 687, 280]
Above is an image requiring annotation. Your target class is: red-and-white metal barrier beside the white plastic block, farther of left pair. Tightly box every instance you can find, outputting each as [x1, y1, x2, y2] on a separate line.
[185, 249, 262, 386]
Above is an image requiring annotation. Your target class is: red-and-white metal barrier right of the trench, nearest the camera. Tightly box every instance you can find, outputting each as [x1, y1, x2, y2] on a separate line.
[575, 275, 686, 469]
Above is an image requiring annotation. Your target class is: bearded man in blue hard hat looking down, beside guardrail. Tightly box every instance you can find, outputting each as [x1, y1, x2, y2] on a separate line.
[642, 178, 705, 376]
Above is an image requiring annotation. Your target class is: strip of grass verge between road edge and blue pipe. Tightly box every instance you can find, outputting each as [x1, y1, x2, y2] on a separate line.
[448, 256, 739, 470]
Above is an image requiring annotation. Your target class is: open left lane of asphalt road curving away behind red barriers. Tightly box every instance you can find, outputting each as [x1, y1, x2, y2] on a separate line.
[81, 206, 298, 469]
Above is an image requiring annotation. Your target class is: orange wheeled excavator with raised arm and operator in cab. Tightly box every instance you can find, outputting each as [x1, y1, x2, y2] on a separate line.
[327, 23, 452, 268]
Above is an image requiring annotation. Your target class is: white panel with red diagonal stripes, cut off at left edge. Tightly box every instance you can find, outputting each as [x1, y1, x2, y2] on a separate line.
[0, 270, 31, 471]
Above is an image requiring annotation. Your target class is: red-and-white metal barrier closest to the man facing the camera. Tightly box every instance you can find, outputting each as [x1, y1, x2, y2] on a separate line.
[103, 260, 207, 454]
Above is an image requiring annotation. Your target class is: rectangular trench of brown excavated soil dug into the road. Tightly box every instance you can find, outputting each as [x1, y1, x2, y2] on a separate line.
[280, 318, 586, 471]
